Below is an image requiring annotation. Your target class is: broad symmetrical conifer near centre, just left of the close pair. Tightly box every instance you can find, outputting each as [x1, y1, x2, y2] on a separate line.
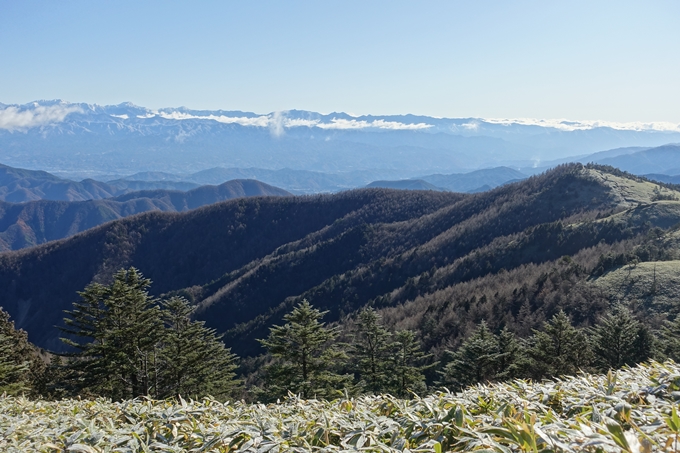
[258, 300, 351, 398]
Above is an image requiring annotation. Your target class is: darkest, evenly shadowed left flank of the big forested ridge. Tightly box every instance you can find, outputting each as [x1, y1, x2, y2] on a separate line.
[0, 190, 461, 349]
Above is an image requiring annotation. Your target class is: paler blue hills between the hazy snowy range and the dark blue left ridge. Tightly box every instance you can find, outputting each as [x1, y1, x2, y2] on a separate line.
[0, 161, 527, 203]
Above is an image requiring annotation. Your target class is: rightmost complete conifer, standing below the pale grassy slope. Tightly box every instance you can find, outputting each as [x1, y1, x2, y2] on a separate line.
[590, 305, 652, 369]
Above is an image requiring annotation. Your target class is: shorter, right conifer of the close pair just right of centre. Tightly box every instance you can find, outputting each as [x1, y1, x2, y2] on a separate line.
[390, 330, 434, 397]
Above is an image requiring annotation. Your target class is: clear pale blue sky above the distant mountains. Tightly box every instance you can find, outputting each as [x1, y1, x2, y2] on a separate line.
[0, 0, 680, 123]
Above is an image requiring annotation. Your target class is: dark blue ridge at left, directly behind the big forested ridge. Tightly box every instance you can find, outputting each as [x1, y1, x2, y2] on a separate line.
[0, 180, 291, 252]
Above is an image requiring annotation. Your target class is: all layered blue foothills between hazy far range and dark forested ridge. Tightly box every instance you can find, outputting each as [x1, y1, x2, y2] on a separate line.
[0, 161, 540, 252]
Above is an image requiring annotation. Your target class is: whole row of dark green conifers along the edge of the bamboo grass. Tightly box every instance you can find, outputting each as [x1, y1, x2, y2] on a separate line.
[0, 268, 680, 401]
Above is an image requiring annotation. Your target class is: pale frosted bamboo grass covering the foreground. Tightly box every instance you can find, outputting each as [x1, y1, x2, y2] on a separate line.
[0, 362, 680, 453]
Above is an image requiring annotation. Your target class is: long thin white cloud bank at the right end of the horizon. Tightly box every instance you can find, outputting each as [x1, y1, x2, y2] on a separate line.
[484, 118, 680, 132]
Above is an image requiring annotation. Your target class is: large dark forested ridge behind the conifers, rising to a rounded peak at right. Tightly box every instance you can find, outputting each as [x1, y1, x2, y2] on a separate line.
[0, 165, 680, 355]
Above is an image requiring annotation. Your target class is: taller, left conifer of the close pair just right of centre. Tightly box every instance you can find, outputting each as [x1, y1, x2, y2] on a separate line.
[350, 308, 392, 393]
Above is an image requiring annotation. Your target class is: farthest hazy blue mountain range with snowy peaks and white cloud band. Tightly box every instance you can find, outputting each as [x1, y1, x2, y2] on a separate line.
[0, 101, 680, 178]
